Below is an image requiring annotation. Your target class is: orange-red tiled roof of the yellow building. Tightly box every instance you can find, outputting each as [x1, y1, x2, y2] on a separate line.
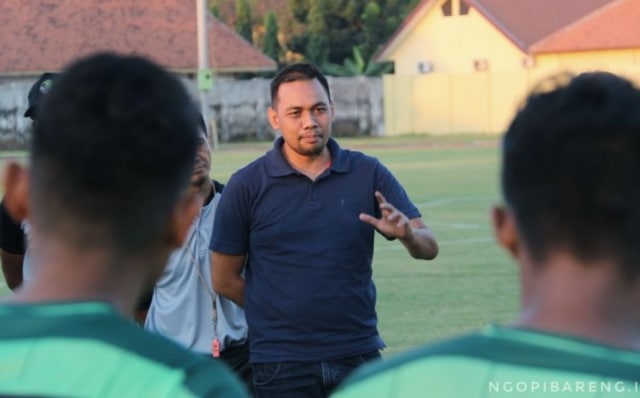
[376, 0, 640, 61]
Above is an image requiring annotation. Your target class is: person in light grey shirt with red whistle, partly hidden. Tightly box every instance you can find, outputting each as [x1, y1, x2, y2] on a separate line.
[144, 115, 251, 390]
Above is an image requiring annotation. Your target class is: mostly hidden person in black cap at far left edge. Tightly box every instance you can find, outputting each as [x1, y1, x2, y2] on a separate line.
[0, 72, 58, 290]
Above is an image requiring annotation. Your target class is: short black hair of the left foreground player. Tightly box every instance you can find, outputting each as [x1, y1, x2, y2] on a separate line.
[31, 53, 199, 251]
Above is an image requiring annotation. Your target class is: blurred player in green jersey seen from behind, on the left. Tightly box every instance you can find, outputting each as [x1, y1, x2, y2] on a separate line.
[0, 53, 246, 398]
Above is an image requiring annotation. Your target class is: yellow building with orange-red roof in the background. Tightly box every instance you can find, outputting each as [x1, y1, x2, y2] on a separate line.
[375, 0, 640, 135]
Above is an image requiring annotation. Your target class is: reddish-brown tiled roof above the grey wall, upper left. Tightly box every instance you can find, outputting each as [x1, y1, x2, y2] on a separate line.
[0, 0, 276, 75]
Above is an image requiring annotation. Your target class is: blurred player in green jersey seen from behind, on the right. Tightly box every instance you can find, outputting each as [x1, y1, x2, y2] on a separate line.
[335, 72, 640, 398]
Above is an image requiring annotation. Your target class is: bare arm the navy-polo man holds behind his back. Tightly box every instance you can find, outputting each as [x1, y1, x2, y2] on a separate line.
[211, 251, 246, 307]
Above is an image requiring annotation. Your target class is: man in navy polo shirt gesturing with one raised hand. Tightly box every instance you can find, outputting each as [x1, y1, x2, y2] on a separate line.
[211, 63, 438, 397]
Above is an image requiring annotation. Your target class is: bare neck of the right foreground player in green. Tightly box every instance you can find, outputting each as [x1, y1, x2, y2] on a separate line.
[515, 256, 640, 351]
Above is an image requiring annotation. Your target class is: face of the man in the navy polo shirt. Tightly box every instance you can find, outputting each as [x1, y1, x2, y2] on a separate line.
[269, 79, 333, 156]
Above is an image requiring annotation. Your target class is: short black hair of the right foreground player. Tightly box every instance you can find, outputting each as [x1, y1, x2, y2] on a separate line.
[501, 72, 640, 277]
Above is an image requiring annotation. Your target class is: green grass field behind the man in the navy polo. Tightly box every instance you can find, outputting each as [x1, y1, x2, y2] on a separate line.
[0, 136, 518, 355]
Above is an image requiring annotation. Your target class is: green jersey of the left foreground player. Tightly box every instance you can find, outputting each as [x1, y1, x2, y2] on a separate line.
[0, 302, 247, 398]
